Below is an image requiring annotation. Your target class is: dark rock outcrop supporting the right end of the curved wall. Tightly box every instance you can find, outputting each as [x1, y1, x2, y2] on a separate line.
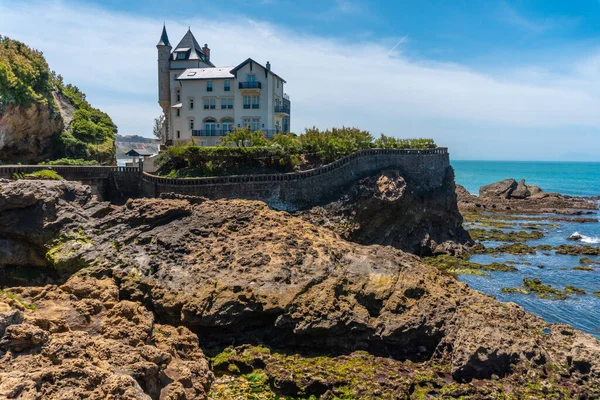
[297, 168, 472, 256]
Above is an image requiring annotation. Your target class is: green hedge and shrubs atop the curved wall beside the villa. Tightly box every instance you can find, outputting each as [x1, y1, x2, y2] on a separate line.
[160, 127, 436, 177]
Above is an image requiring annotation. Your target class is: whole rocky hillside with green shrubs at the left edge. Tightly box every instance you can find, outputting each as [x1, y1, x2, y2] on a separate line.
[0, 35, 117, 164]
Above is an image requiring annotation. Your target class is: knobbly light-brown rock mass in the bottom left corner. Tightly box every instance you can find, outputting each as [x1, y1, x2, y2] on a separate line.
[0, 277, 213, 400]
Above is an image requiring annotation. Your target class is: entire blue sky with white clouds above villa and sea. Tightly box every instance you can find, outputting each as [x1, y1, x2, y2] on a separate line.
[0, 0, 600, 161]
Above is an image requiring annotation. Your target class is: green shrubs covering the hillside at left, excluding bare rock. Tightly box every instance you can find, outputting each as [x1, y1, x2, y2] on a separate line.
[0, 36, 117, 163]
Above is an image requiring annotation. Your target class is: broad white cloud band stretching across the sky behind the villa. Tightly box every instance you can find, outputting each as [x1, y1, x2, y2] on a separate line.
[0, 0, 600, 158]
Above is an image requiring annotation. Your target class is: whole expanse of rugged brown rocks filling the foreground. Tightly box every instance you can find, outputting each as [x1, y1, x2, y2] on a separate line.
[0, 180, 600, 399]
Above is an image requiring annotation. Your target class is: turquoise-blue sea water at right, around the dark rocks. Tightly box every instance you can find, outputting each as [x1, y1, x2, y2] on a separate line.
[452, 161, 600, 337]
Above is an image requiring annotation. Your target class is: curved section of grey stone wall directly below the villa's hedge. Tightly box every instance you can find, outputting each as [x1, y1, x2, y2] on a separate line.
[142, 148, 450, 211]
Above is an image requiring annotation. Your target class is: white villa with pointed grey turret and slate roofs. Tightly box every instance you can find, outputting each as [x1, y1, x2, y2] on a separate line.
[156, 26, 290, 146]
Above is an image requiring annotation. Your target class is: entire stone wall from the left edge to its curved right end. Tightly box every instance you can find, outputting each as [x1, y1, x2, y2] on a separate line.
[0, 147, 450, 211]
